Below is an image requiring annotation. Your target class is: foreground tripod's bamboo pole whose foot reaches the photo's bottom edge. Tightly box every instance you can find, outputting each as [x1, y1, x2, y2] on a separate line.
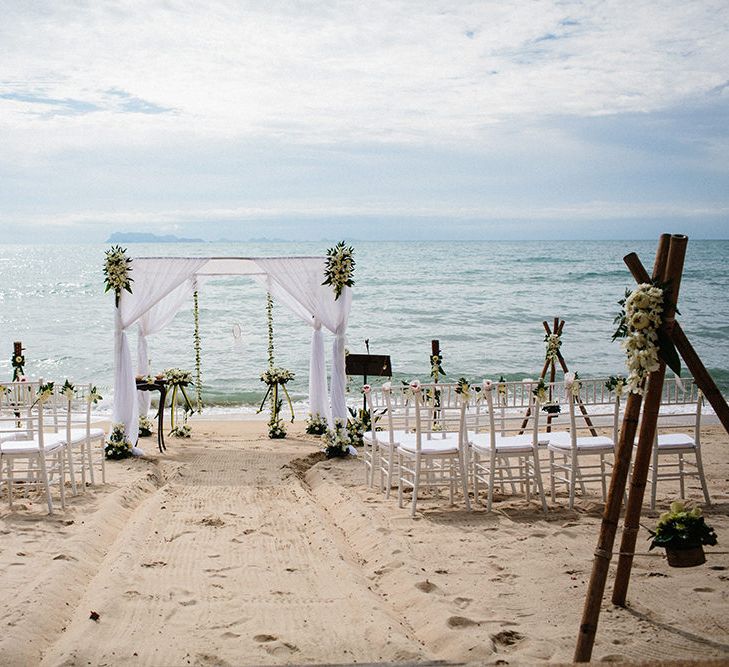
[574, 237, 667, 662]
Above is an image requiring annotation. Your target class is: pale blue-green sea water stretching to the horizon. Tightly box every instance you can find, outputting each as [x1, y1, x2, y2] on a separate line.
[0, 241, 729, 406]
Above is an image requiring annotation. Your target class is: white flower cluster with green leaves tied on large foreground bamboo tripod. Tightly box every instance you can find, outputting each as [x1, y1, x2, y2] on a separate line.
[613, 283, 681, 394]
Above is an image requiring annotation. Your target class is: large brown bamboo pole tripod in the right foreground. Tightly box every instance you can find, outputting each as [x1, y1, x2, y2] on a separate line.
[574, 234, 729, 662]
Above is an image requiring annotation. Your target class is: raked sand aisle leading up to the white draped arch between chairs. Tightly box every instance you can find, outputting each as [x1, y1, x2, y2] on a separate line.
[44, 446, 428, 665]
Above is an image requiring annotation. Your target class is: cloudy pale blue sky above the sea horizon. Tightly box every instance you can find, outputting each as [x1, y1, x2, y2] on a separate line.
[0, 0, 729, 243]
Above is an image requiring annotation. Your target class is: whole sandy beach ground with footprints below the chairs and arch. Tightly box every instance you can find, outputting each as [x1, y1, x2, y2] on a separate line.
[0, 419, 729, 665]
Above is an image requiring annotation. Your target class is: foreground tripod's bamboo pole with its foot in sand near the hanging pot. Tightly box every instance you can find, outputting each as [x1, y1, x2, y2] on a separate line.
[612, 235, 688, 607]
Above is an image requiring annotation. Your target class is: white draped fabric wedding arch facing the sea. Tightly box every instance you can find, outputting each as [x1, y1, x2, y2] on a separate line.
[113, 256, 352, 443]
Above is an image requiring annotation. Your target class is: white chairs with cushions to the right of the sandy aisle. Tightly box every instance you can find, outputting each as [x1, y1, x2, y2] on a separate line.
[362, 375, 710, 516]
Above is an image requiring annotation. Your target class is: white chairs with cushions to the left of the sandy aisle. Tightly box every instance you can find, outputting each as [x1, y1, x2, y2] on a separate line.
[0, 379, 106, 514]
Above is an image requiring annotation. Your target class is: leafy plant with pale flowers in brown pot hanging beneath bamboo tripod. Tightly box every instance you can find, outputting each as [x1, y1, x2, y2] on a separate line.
[648, 501, 716, 567]
